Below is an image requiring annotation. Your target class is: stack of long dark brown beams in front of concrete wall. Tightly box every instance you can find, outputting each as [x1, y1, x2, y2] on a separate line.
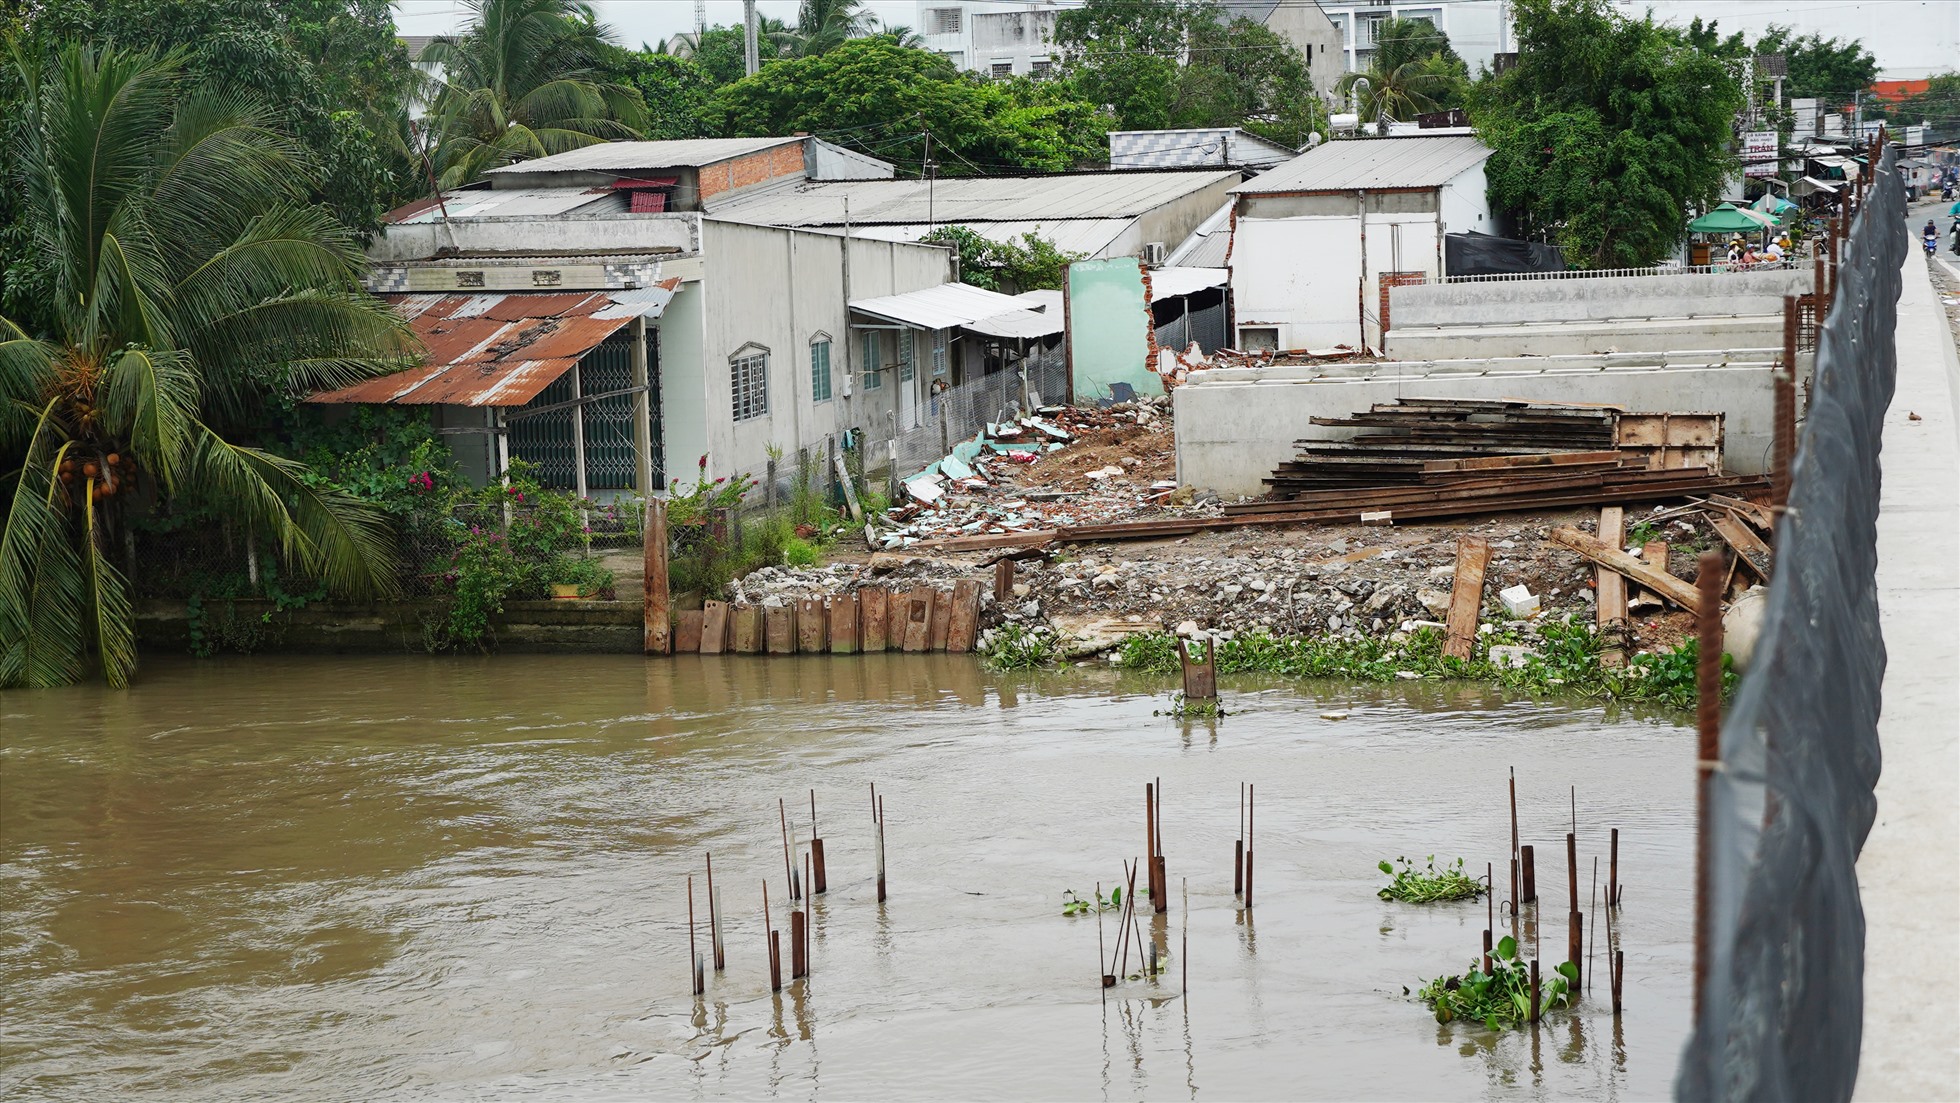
[1225, 398, 1766, 521]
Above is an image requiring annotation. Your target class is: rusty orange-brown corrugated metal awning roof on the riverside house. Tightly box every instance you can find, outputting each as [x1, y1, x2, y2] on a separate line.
[308, 280, 680, 406]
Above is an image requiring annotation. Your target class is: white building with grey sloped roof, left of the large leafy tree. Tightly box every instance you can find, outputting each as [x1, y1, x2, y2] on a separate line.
[1229, 135, 1495, 349]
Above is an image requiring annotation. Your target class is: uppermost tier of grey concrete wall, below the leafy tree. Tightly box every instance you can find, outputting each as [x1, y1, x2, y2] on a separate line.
[1388, 268, 1813, 327]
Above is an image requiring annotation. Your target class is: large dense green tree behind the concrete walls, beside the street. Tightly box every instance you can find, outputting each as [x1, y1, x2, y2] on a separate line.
[1470, 0, 1742, 268]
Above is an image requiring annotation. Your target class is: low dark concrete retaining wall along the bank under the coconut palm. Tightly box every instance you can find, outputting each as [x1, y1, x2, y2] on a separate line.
[137, 599, 643, 654]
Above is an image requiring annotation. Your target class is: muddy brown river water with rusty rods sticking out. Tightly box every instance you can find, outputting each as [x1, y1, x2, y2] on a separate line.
[0, 654, 1693, 1101]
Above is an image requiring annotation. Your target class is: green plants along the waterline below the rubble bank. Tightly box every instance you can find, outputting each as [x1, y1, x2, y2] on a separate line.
[1117, 617, 1735, 709]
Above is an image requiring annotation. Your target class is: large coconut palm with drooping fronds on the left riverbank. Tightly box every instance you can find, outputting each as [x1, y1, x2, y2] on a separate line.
[0, 45, 410, 686]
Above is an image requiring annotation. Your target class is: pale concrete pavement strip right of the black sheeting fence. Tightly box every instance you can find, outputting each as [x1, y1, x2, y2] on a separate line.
[1854, 208, 1960, 1101]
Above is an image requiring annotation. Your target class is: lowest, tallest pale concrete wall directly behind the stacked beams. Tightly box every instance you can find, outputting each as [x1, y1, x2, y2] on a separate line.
[1172, 349, 1774, 494]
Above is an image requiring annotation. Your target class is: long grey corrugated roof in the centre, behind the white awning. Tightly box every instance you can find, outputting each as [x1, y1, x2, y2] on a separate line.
[711, 170, 1239, 225]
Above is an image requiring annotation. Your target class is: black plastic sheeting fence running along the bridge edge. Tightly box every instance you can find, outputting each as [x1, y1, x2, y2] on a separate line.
[1674, 149, 1907, 1099]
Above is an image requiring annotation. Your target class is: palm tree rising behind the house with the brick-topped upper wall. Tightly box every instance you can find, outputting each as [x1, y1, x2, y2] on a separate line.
[421, 0, 647, 188]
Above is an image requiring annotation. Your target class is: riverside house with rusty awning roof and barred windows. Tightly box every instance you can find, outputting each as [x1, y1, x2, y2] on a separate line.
[312, 137, 955, 496]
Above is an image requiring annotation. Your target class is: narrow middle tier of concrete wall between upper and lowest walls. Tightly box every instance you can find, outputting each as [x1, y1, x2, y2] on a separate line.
[1386, 313, 1784, 360]
